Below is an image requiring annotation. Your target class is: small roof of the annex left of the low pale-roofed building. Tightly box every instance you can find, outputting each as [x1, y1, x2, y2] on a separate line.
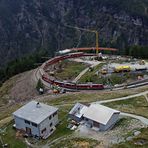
[69, 103, 88, 118]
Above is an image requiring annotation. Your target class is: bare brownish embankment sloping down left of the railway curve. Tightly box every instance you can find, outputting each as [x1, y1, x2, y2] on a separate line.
[0, 70, 38, 107]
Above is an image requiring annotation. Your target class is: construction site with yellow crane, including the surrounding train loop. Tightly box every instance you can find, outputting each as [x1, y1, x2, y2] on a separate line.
[36, 26, 148, 92]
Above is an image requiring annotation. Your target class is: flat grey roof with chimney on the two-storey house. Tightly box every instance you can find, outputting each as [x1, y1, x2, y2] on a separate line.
[13, 101, 58, 124]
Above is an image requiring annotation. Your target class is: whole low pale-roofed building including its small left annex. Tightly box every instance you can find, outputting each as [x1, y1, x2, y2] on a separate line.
[69, 103, 120, 131]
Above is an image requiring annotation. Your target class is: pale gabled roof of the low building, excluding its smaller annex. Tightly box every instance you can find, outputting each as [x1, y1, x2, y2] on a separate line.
[83, 104, 120, 125]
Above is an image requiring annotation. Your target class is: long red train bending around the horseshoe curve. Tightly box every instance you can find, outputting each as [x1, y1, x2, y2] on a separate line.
[40, 52, 104, 90]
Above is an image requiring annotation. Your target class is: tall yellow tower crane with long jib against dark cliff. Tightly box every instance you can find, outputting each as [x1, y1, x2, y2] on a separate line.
[65, 25, 99, 55]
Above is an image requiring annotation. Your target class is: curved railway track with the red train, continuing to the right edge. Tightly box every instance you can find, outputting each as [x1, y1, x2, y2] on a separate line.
[36, 47, 148, 90]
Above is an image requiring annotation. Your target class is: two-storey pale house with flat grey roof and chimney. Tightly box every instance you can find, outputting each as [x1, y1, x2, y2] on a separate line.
[13, 101, 58, 139]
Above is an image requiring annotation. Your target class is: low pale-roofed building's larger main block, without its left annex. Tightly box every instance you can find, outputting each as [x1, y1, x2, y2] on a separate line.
[83, 104, 120, 131]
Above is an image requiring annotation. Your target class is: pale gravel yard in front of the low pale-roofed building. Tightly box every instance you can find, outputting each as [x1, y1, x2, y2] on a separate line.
[75, 118, 146, 147]
